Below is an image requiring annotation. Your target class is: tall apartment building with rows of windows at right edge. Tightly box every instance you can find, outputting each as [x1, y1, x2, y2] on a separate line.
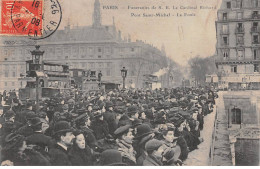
[215, 0, 260, 89]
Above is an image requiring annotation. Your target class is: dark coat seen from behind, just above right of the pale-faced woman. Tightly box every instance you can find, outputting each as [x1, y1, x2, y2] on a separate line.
[90, 119, 109, 140]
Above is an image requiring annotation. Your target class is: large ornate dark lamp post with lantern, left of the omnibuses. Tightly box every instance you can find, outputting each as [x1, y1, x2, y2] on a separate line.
[31, 45, 44, 111]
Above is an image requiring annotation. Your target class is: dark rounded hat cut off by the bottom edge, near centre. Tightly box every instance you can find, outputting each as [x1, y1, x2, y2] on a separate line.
[100, 149, 126, 166]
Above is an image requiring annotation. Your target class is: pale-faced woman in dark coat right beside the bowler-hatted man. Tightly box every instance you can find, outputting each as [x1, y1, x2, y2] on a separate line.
[68, 131, 95, 166]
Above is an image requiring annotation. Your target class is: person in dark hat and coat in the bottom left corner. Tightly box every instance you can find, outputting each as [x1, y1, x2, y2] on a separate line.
[1, 133, 50, 166]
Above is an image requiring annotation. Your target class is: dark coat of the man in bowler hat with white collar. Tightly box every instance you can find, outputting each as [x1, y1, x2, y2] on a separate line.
[49, 144, 71, 166]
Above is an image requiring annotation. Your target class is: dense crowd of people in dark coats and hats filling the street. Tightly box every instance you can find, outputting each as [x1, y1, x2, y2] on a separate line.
[0, 87, 217, 166]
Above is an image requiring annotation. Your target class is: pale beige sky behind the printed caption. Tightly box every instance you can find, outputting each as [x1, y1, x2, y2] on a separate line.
[56, 0, 221, 66]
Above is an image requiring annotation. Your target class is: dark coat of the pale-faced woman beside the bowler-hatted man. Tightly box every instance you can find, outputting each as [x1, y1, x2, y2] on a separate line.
[68, 145, 94, 166]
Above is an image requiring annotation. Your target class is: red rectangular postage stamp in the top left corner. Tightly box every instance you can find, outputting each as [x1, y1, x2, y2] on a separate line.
[0, 0, 43, 36]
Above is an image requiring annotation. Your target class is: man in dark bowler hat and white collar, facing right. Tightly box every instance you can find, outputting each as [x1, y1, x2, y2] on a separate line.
[49, 121, 75, 166]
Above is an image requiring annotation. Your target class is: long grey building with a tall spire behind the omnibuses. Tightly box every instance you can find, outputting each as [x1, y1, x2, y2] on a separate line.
[0, 0, 167, 91]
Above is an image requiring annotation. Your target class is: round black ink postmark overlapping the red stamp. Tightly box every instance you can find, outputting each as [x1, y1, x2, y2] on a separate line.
[11, 0, 62, 40]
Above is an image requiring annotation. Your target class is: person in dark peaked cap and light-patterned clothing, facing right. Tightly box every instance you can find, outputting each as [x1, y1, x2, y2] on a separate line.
[114, 125, 136, 166]
